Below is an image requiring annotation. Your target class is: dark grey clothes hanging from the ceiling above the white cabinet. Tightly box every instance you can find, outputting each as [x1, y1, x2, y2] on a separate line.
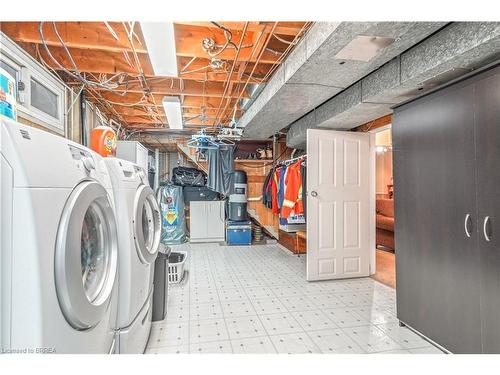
[207, 145, 234, 195]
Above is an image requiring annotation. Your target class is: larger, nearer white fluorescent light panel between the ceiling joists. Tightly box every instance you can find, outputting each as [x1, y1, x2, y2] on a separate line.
[141, 22, 178, 77]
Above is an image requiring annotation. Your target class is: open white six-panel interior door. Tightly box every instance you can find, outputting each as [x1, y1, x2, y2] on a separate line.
[307, 129, 375, 281]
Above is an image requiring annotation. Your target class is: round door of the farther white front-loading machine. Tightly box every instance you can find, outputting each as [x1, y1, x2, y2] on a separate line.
[134, 185, 161, 263]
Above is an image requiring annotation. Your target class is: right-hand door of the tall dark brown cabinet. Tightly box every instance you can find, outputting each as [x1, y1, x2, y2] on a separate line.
[474, 69, 500, 353]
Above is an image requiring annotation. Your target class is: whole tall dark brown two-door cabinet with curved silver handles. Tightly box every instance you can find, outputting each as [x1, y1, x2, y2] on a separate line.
[393, 62, 500, 353]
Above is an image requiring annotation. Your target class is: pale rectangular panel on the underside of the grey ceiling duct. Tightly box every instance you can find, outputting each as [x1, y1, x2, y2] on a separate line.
[335, 35, 394, 62]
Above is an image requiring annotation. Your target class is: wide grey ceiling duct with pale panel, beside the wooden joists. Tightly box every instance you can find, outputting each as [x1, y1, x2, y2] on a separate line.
[238, 22, 446, 139]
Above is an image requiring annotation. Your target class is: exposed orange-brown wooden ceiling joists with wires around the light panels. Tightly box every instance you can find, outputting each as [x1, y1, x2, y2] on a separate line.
[0, 21, 309, 129]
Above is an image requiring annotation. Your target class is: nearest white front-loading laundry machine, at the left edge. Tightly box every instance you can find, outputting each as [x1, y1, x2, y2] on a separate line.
[0, 119, 118, 353]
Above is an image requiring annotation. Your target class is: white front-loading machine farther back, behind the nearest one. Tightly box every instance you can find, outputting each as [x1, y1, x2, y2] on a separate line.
[105, 158, 161, 353]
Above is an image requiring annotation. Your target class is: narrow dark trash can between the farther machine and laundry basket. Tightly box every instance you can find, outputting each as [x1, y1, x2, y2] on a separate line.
[152, 244, 171, 322]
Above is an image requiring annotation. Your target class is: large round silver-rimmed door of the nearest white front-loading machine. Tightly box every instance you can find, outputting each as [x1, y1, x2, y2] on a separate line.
[55, 181, 118, 330]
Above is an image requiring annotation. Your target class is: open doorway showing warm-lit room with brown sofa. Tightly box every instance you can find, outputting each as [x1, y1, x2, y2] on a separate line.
[372, 124, 396, 288]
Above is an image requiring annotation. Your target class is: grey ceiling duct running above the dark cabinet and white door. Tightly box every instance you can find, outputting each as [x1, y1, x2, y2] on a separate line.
[287, 22, 500, 148]
